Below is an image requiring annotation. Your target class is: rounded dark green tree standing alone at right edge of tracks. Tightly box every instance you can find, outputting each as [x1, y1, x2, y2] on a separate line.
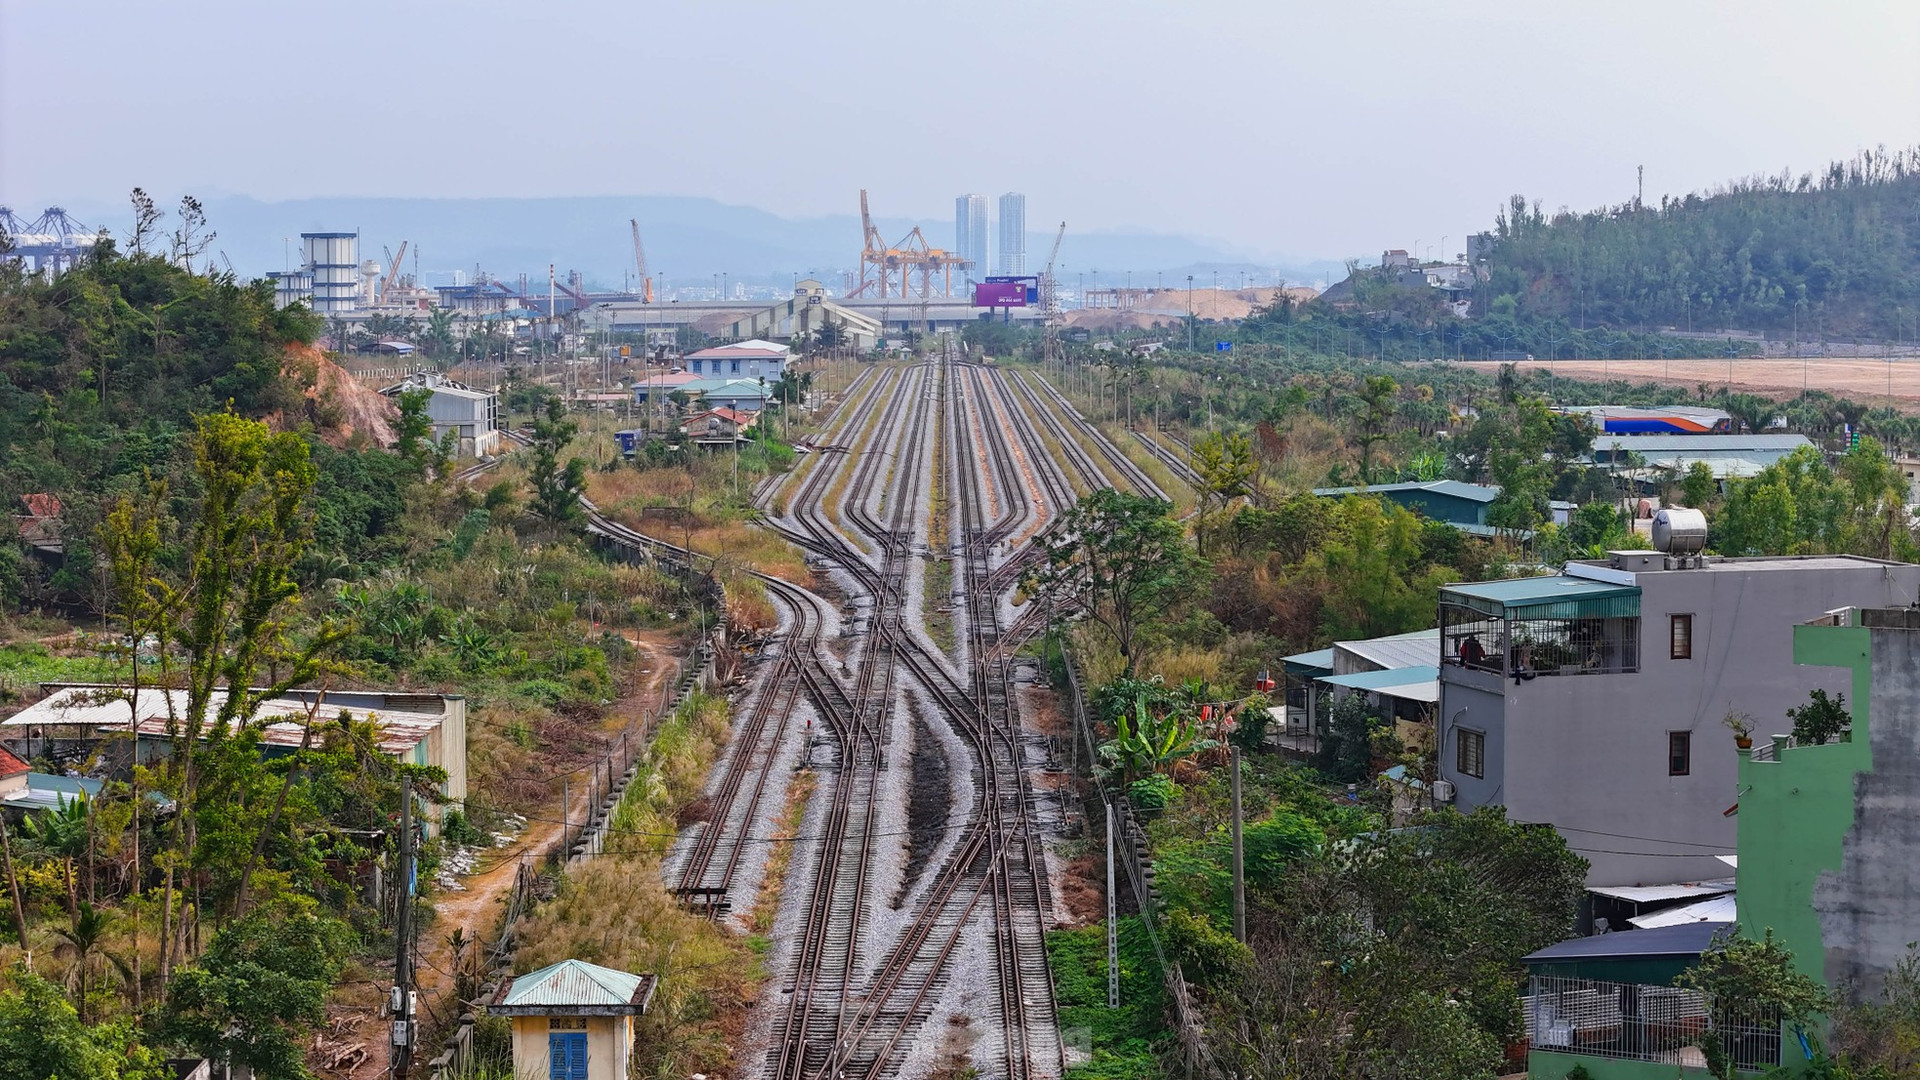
[1029, 488, 1206, 675]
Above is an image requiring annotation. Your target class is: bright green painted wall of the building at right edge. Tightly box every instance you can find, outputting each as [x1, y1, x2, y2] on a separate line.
[1738, 626, 1872, 982]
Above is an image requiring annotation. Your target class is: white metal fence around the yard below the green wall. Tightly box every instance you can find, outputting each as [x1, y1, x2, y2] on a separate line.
[1523, 974, 1780, 1072]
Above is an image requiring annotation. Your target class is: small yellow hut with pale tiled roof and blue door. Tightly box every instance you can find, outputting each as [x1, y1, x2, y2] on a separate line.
[488, 961, 657, 1080]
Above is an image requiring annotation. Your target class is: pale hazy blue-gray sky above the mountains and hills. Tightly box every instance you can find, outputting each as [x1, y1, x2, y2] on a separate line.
[0, 0, 1920, 258]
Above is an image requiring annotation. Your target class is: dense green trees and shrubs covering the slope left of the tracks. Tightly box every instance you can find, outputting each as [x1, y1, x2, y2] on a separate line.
[0, 205, 725, 1080]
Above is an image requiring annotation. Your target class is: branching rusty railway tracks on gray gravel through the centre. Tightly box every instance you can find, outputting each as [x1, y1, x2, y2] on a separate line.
[588, 348, 1160, 1080]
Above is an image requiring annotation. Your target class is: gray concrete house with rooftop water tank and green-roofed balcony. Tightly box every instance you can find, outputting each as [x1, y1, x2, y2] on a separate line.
[1434, 552, 1920, 886]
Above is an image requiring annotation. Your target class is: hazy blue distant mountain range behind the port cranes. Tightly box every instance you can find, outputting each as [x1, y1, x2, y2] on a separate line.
[45, 196, 1340, 288]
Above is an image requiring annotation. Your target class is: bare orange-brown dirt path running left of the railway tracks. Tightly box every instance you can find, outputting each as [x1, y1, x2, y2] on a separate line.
[320, 630, 680, 1080]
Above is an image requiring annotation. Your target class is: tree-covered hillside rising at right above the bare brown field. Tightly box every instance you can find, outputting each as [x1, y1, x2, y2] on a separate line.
[1475, 148, 1920, 342]
